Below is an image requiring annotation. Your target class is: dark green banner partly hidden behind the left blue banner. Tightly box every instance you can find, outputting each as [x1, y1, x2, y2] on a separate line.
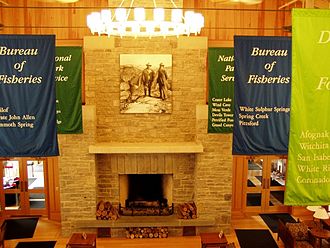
[55, 47, 83, 134]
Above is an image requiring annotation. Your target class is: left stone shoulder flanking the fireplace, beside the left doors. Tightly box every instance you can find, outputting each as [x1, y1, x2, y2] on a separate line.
[58, 106, 96, 236]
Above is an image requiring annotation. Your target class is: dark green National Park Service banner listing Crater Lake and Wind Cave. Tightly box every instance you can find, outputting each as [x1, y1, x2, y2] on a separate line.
[208, 48, 234, 133]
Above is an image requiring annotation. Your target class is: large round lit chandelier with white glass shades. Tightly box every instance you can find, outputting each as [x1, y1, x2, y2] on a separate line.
[87, 0, 204, 38]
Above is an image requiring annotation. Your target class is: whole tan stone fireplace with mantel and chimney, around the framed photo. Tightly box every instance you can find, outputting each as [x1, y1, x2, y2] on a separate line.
[58, 37, 232, 235]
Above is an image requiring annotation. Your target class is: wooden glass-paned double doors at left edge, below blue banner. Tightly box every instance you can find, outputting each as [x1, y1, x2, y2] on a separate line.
[0, 158, 48, 216]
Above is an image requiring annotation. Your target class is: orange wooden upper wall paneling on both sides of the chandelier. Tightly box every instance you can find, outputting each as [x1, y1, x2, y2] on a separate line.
[0, 0, 302, 41]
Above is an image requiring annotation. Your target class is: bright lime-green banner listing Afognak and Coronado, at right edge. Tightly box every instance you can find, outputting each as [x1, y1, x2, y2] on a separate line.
[285, 9, 330, 206]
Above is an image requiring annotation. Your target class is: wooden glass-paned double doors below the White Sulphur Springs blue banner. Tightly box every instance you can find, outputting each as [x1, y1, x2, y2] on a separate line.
[232, 155, 291, 214]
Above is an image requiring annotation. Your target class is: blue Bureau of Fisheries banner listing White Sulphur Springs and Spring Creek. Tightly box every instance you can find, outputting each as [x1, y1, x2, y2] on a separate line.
[233, 36, 291, 155]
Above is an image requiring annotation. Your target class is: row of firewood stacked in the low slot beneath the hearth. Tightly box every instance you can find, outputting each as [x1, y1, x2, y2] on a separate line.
[126, 227, 168, 239]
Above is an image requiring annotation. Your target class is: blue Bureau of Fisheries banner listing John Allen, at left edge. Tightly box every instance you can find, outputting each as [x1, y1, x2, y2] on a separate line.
[0, 35, 59, 157]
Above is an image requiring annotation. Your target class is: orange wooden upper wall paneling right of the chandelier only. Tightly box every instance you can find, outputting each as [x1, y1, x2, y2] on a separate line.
[197, 0, 299, 41]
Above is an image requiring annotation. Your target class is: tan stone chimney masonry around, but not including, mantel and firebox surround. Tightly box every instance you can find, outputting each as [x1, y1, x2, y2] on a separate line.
[60, 37, 232, 236]
